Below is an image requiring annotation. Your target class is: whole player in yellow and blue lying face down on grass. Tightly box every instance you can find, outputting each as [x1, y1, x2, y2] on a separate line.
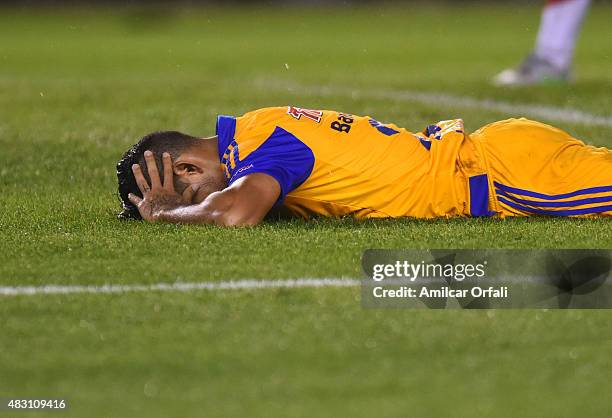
[117, 106, 612, 225]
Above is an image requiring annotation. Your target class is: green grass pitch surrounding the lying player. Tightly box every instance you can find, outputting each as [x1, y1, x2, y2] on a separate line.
[0, 3, 612, 417]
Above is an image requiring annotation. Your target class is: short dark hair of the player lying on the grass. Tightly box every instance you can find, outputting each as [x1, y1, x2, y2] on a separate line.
[117, 131, 199, 219]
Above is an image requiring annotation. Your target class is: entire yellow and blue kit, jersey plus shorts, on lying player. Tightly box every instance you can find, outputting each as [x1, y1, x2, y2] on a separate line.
[217, 106, 612, 218]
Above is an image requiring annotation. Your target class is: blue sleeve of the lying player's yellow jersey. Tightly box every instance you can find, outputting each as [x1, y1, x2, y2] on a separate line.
[221, 121, 315, 204]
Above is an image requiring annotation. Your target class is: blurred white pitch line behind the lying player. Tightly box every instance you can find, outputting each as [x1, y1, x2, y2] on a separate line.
[256, 80, 612, 127]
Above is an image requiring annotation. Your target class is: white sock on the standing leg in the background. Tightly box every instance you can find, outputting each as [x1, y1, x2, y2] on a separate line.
[535, 0, 591, 70]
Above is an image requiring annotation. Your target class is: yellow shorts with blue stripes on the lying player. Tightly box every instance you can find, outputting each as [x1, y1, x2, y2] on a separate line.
[468, 119, 612, 217]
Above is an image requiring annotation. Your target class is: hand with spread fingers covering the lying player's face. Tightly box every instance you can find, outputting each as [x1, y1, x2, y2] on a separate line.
[128, 151, 195, 222]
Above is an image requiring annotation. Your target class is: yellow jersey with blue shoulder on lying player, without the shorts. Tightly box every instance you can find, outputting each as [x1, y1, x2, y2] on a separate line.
[217, 106, 482, 218]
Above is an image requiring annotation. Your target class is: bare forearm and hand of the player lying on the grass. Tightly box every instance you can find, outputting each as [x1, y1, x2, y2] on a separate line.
[129, 153, 280, 226]
